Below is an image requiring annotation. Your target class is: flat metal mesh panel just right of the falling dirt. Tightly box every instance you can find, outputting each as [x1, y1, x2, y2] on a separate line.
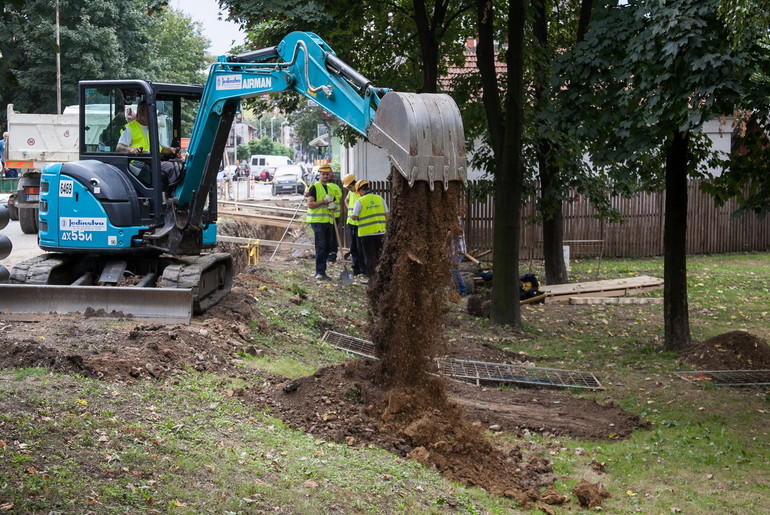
[436, 358, 603, 390]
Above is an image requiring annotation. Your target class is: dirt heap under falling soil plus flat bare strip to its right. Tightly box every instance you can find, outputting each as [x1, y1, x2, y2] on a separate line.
[246, 358, 647, 505]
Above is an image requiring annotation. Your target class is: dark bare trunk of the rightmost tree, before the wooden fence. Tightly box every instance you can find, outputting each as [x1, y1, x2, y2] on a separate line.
[663, 131, 691, 351]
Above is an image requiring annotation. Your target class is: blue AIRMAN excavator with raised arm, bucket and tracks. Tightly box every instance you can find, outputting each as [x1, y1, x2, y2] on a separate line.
[0, 32, 466, 318]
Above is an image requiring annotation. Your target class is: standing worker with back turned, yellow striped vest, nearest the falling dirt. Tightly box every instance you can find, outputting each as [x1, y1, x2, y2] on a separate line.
[352, 180, 388, 284]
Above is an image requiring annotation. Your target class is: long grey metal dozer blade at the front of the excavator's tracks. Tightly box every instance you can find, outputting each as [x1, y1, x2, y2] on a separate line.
[0, 284, 193, 324]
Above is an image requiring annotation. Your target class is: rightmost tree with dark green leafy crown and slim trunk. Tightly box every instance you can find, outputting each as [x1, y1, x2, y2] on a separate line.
[556, 0, 770, 350]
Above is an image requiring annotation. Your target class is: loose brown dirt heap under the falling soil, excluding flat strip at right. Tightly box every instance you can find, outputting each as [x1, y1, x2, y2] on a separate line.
[252, 359, 540, 504]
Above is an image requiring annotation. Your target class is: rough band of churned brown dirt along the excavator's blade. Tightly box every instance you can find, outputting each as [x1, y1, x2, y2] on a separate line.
[0, 278, 265, 381]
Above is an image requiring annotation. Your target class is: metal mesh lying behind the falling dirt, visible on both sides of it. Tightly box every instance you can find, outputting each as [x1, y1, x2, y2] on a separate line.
[321, 331, 603, 390]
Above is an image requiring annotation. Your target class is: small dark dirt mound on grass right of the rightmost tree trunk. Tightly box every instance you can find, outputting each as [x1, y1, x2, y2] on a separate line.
[681, 331, 770, 370]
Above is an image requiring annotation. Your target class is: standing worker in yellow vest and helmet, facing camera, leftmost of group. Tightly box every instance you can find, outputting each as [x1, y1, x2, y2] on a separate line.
[305, 165, 339, 281]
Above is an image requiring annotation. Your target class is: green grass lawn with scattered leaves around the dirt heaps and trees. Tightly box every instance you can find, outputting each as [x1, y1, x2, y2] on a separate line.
[0, 253, 770, 514]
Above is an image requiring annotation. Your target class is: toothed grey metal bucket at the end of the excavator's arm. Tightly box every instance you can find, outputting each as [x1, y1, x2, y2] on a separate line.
[367, 91, 467, 189]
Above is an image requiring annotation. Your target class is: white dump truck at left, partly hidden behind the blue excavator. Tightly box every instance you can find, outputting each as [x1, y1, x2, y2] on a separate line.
[5, 104, 79, 234]
